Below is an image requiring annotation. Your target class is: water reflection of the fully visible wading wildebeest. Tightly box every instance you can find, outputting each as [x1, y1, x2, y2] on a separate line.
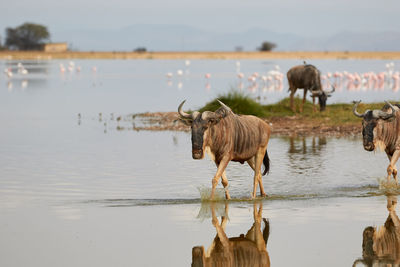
[192, 202, 270, 267]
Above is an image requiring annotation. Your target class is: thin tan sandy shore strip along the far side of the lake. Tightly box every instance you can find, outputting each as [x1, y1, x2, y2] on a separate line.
[0, 51, 400, 60]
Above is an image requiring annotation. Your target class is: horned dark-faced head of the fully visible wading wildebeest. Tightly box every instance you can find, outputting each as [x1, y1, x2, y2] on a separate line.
[178, 100, 232, 159]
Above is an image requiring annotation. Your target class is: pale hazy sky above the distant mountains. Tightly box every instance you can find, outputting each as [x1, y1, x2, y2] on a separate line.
[0, 0, 400, 38]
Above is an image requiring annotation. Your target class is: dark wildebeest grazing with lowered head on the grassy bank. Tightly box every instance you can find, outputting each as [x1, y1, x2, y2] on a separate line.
[287, 64, 335, 112]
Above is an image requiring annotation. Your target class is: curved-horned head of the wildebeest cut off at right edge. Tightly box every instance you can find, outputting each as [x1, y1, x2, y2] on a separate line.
[353, 100, 396, 151]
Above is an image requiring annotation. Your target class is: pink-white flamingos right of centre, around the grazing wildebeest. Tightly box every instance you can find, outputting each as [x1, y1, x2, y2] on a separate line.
[166, 61, 400, 93]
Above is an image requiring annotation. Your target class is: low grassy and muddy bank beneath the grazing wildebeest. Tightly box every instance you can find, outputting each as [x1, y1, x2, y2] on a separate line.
[127, 93, 388, 137]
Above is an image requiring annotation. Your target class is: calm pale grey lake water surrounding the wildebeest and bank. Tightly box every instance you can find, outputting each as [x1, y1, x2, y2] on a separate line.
[0, 60, 400, 266]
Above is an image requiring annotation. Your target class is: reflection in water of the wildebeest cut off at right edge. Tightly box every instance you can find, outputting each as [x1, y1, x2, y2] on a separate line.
[353, 196, 400, 266]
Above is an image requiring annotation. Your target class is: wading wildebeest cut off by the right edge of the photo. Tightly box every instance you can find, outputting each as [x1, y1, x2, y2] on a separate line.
[353, 100, 400, 183]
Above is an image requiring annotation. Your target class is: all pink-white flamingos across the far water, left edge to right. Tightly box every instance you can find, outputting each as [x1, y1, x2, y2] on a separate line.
[4, 60, 400, 93]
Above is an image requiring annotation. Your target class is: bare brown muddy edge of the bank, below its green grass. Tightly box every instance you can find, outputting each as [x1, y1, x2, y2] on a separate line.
[130, 112, 361, 137]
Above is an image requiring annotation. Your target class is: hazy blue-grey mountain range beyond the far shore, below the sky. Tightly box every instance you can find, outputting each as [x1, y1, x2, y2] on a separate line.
[52, 25, 400, 51]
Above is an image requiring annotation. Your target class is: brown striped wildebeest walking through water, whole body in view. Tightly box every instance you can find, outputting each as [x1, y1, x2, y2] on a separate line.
[178, 100, 271, 200]
